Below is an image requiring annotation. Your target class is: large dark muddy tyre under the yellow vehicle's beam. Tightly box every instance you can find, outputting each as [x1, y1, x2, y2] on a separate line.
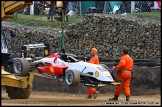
[6, 86, 32, 99]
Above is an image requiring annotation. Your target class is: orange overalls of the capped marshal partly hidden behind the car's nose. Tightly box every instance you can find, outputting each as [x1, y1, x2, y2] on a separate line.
[87, 55, 99, 96]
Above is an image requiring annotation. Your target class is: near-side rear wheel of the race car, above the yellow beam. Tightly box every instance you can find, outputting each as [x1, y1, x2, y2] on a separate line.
[12, 58, 30, 76]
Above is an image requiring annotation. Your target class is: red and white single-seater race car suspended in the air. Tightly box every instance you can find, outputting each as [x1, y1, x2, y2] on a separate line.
[8, 53, 120, 87]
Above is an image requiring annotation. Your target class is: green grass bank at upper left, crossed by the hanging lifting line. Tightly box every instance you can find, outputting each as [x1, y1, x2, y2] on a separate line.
[6, 14, 80, 29]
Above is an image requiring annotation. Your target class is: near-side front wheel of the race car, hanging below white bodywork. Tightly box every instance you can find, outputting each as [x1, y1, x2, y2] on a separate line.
[65, 69, 80, 87]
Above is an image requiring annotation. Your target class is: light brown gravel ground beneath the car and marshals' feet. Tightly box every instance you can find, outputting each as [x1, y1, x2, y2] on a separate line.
[1, 90, 161, 106]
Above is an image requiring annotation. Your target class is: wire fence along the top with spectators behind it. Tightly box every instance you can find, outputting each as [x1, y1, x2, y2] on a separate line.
[15, 1, 161, 21]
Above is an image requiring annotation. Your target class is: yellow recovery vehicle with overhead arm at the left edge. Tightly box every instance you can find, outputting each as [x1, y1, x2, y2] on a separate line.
[1, 1, 34, 99]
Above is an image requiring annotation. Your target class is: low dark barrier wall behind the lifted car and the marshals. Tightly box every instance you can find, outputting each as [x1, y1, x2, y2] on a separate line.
[33, 66, 161, 95]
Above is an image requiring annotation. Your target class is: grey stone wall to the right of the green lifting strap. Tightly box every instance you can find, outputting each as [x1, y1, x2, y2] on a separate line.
[66, 14, 161, 59]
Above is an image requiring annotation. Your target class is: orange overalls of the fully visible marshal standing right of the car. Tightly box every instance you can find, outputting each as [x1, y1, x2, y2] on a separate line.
[115, 54, 134, 96]
